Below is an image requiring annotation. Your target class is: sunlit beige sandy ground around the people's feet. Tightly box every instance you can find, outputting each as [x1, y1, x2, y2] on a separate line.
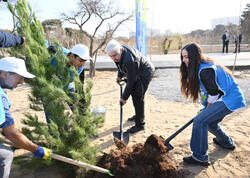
[5, 71, 250, 178]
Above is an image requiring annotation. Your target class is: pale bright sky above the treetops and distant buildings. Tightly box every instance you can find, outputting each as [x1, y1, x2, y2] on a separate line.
[0, 0, 250, 35]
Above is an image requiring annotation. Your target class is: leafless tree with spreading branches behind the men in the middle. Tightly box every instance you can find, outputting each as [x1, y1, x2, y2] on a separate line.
[62, 0, 133, 77]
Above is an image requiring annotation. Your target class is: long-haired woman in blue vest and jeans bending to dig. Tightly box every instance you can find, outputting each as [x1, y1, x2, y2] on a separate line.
[180, 43, 246, 166]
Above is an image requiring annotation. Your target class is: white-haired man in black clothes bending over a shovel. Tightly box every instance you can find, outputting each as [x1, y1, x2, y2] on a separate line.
[106, 40, 155, 133]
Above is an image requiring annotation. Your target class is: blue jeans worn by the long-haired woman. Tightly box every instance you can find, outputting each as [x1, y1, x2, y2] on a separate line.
[190, 101, 233, 161]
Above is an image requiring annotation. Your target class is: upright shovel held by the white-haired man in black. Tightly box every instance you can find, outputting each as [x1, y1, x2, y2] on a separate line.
[113, 82, 129, 145]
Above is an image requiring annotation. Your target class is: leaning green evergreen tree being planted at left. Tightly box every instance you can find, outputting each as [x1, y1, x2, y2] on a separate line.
[8, 0, 103, 175]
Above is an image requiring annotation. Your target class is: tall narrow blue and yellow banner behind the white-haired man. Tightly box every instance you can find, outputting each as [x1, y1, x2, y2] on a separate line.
[135, 0, 147, 56]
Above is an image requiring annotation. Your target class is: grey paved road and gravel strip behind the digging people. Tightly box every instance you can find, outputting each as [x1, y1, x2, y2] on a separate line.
[87, 52, 250, 104]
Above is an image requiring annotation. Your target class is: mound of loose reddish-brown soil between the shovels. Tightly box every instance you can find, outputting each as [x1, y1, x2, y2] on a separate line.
[87, 134, 183, 178]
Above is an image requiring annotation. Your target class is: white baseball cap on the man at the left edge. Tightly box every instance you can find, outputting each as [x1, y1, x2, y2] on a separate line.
[0, 57, 35, 78]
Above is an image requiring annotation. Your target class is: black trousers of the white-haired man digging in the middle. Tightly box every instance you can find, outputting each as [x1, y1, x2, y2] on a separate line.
[131, 77, 152, 127]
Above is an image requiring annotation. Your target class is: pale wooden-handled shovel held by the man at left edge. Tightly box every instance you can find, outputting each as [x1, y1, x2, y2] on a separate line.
[0, 138, 114, 176]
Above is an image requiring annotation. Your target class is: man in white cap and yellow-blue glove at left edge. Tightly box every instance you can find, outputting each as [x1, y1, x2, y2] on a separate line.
[0, 57, 51, 178]
